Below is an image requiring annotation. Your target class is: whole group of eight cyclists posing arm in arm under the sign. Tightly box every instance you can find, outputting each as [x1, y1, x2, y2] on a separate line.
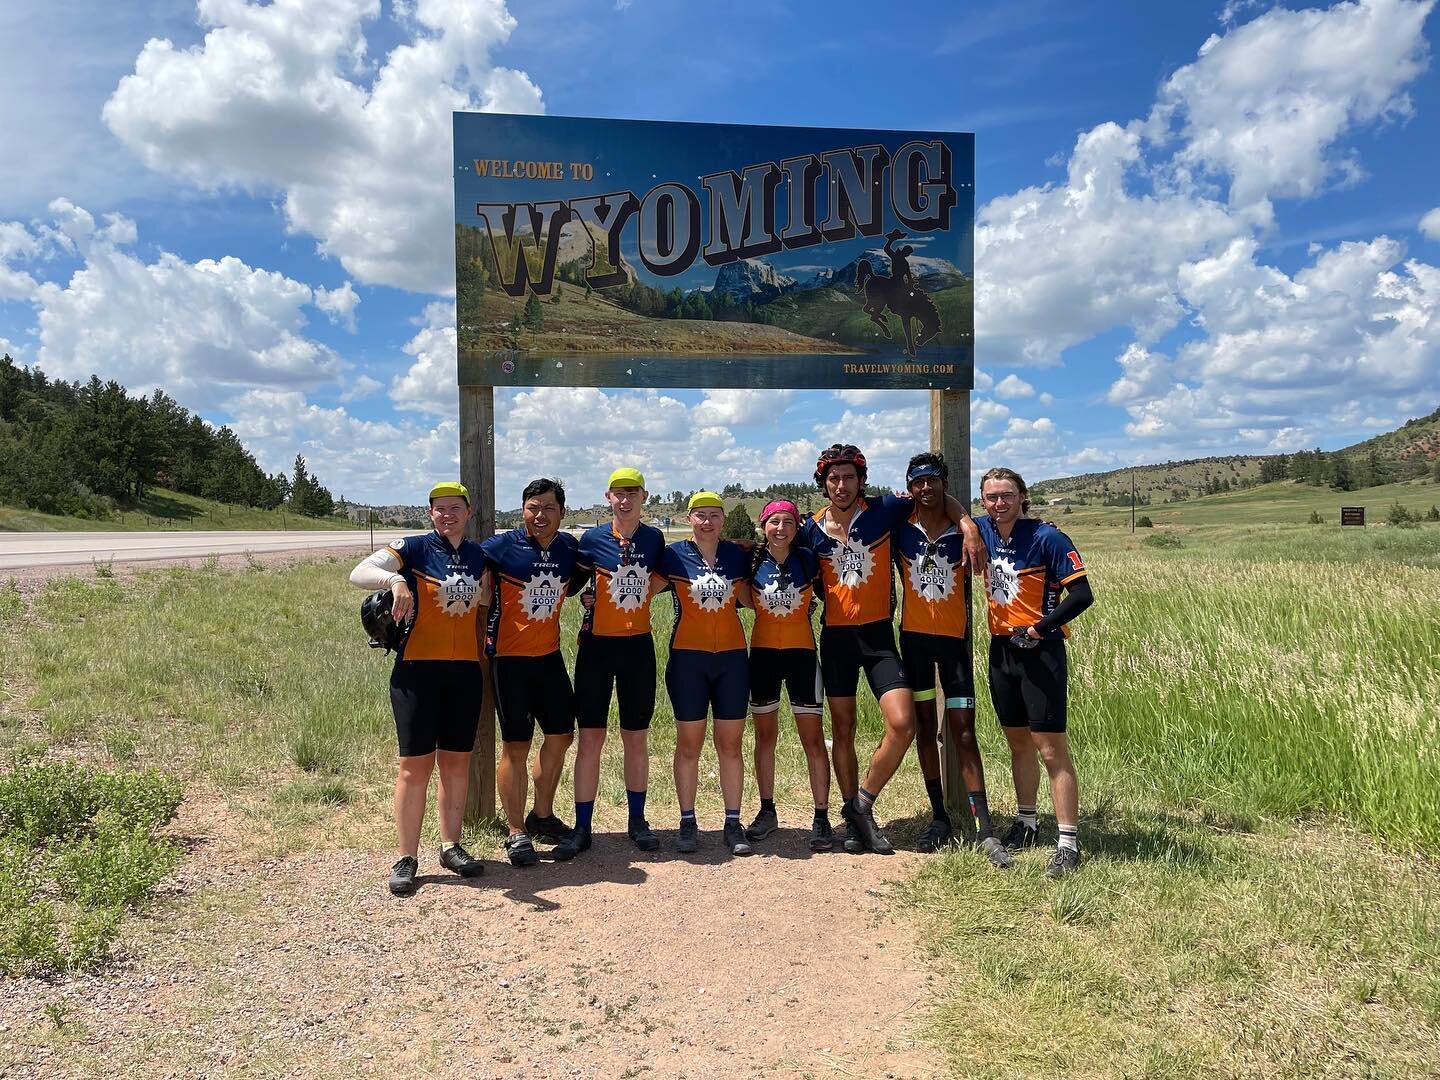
[350, 444, 1093, 894]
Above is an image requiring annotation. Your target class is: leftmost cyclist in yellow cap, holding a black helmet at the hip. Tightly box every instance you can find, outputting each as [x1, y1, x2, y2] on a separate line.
[350, 482, 490, 896]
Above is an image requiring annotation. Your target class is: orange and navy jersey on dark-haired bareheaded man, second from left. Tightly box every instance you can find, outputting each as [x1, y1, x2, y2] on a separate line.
[480, 528, 576, 657]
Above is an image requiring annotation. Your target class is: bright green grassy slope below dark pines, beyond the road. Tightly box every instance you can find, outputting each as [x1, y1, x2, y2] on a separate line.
[0, 488, 361, 533]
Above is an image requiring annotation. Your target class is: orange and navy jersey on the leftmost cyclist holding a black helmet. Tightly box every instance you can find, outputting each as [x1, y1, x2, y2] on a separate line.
[386, 531, 485, 661]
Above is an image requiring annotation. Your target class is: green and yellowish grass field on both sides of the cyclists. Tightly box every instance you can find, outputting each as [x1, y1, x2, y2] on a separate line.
[0, 513, 1440, 1077]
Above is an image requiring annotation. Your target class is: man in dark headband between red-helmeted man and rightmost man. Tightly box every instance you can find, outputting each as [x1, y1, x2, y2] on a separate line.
[894, 452, 1012, 867]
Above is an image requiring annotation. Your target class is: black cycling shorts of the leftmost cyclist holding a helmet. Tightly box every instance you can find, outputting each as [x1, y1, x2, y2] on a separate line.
[390, 660, 485, 757]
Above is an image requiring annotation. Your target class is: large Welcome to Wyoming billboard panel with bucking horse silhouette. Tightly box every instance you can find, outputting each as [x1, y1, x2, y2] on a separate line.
[455, 112, 975, 390]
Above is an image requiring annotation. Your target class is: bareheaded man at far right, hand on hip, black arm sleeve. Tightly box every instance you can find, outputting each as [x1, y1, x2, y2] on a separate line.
[979, 468, 1094, 878]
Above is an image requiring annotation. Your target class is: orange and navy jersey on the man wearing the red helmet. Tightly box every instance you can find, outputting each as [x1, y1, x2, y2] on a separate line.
[799, 495, 914, 626]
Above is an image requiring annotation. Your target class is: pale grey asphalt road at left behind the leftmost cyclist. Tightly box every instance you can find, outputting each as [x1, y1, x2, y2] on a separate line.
[0, 528, 415, 572]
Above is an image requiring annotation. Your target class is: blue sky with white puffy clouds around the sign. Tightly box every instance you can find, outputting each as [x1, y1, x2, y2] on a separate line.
[0, 0, 1440, 505]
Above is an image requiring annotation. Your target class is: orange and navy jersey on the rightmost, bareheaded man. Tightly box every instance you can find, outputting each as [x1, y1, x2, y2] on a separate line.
[975, 516, 1086, 639]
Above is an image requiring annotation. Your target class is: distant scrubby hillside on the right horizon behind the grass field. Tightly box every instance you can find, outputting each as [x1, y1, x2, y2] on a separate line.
[1031, 409, 1440, 504]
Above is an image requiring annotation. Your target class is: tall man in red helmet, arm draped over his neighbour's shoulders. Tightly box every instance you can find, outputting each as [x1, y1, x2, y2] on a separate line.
[801, 442, 984, 855]
